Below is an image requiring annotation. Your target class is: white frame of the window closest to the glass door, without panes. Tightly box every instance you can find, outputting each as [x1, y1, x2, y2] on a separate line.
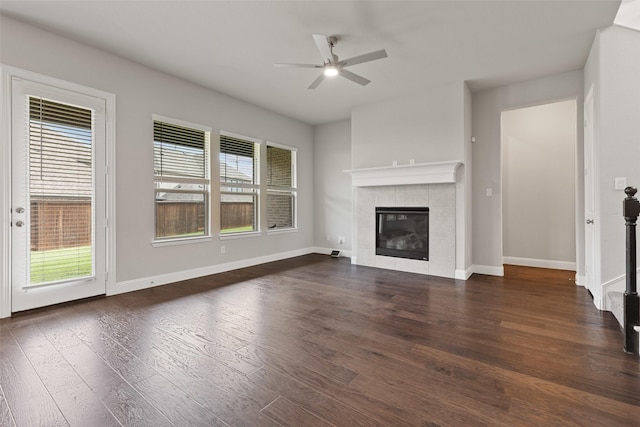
[151, 114, 213, 247]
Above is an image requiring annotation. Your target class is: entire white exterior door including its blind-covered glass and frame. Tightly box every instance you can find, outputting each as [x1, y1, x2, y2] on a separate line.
[0, 70, 113, 317]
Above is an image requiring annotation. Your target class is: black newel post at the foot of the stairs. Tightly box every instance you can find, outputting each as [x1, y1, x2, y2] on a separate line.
[622, 187, 640, 354]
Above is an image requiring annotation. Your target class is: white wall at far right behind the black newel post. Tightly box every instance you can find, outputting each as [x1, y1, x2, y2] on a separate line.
[584, 26, 640, 288]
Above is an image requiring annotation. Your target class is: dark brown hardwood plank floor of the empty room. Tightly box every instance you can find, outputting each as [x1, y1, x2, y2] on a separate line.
[0, 255, 640, 427]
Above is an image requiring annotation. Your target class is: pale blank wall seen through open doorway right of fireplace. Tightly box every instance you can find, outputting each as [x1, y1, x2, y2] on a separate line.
[502, 100, 576, 269]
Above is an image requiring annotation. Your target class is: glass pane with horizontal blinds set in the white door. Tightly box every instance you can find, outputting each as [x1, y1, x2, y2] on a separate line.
[28, 96, 94, 285]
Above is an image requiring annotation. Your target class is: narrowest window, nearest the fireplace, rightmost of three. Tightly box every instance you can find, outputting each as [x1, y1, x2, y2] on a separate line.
[267, 143, 296, 229]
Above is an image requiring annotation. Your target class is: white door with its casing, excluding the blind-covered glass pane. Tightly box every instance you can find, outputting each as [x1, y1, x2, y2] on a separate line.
[0, 66, 115, 318]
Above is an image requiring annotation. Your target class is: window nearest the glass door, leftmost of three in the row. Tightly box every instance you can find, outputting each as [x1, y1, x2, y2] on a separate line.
[153, 116, 211, 240]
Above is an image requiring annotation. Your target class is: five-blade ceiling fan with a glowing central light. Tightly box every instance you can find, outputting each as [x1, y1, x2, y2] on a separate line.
[273, 34, 387, 89]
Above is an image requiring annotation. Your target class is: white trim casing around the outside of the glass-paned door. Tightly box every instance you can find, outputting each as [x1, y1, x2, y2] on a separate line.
[0, 64, 116, 318]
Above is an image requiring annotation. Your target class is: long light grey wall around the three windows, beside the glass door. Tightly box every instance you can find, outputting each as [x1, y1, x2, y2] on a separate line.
[0, 16, 314, 290]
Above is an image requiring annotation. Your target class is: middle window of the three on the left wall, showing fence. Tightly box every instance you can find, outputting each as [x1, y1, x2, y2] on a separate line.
[219, 134, 260, 234]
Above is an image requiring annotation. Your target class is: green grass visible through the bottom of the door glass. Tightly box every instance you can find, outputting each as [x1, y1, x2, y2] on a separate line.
[31, 246, 92, 284]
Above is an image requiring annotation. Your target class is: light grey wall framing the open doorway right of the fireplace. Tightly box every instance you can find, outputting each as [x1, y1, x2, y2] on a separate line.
[472, 71, 584, 276]
